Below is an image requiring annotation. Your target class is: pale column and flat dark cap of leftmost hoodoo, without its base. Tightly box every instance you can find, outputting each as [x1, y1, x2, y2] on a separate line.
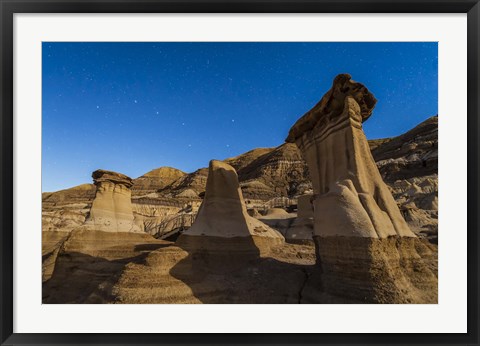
[85, 169, 139, 232]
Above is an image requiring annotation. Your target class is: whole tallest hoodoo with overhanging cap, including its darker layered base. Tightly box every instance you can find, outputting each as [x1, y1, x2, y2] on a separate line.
[286, 74, 437, 303]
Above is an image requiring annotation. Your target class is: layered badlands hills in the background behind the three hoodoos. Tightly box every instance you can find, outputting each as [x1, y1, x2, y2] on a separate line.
[42, 116, 438, 243]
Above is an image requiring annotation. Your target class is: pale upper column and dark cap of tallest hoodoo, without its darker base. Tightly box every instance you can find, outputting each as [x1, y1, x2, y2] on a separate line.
[287, 74, 415, 238]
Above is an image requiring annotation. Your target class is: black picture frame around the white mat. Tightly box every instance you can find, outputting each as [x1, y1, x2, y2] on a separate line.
[0, 0, 480, 345]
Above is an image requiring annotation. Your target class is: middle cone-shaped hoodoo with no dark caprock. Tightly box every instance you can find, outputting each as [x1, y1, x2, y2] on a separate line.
[176, 160, 284, 268]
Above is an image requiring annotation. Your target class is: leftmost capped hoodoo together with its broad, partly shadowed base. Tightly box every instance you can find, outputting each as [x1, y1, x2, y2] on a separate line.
[43, 170, 166, 304]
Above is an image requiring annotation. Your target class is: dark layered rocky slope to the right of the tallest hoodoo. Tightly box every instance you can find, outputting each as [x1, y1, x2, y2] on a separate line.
[370, 116, 438, 243]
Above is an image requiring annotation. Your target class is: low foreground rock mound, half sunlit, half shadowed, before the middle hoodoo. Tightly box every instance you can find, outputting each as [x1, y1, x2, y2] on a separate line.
[112, 244, 316, 304]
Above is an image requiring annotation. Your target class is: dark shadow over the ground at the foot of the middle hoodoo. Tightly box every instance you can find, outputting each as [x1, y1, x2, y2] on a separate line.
[170, 237, 315, 304]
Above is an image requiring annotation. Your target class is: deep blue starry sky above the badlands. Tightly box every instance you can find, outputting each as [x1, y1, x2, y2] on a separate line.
[42, 42, 438, 191]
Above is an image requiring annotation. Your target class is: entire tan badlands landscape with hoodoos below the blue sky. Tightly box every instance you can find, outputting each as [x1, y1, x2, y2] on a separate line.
[42, 74, 438, 304]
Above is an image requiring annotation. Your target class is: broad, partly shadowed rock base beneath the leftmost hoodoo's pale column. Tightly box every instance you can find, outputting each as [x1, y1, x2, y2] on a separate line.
[42, 228, 171, 304]
